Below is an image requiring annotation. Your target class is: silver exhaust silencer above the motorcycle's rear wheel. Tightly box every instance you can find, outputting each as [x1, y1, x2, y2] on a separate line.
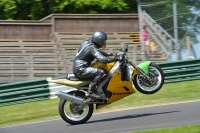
[56, 91, 85, 104]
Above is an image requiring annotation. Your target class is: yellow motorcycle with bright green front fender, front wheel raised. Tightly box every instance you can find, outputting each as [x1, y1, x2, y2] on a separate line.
[47, 45, 164, 125]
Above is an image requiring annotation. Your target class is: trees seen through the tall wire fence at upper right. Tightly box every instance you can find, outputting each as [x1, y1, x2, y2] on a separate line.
[141, 0, 200, 46]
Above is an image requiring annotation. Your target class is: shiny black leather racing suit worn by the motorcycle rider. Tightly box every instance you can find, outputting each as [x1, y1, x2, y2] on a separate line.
[73, 40, 117, 86]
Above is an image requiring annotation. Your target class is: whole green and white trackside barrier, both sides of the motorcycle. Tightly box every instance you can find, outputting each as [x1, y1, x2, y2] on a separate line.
[0, 59, 200, 107]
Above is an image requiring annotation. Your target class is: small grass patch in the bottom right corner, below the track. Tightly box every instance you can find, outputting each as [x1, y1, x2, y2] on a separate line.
[127, 125, 200, 133]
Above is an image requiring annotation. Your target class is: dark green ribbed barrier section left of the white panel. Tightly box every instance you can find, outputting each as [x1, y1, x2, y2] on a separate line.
[0, 78, 50, 107]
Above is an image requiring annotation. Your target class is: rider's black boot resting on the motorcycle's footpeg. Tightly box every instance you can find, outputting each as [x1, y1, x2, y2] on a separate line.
[86, 82, 102, 99]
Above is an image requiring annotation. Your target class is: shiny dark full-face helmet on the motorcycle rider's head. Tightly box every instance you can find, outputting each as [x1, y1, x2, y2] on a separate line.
[92, 31, 107, 48]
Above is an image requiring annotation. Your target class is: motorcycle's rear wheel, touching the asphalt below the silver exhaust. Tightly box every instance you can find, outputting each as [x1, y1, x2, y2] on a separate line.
[58, 91, 94, 125]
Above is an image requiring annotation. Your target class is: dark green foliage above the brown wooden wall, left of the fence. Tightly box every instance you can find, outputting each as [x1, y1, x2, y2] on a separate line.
[0, 0, 137, 20]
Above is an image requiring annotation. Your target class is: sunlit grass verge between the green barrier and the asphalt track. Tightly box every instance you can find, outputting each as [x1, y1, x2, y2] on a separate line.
[0, 80, 200, 126]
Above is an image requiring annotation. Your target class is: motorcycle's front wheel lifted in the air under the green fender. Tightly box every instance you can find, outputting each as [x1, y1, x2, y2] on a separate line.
[133, 63, 164, 94]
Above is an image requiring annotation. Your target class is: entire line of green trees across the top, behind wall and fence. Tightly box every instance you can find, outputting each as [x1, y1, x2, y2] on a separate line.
[0, 0, 200, 44]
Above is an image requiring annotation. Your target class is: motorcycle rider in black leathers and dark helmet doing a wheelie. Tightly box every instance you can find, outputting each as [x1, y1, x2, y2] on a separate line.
[73, 31, 122, 99]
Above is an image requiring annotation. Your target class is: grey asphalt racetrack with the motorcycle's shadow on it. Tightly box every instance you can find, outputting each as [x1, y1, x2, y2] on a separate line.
[0, 101, 200, 133]
